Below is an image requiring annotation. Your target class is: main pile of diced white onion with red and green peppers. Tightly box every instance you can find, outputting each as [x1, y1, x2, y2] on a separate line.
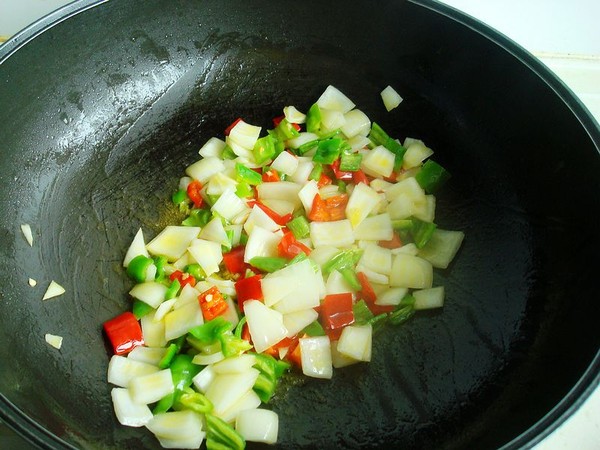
[104, 86, 464, 449]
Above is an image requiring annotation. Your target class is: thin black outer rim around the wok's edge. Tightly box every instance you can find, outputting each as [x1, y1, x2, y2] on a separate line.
[0, 0, 600, 450]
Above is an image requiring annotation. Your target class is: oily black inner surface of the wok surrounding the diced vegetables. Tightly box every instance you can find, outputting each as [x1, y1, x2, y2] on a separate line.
[0, 0, 600, 449]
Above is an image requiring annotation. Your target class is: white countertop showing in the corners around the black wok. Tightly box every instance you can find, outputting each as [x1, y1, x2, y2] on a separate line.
[0, 0, 600, 450]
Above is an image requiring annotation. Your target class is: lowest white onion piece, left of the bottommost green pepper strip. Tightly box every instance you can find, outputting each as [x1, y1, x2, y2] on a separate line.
[146, 410, 205, 449]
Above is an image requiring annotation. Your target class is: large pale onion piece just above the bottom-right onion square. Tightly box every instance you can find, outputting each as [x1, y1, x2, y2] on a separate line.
[206, 368, 260, 416]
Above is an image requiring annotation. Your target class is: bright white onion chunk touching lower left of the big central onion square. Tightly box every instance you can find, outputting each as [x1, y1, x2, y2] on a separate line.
[244, 300, 288, 353]
